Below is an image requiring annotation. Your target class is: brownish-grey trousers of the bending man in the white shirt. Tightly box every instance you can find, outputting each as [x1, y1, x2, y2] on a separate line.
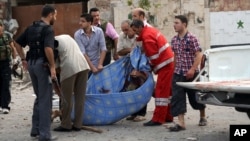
[61, 70, 89, 129]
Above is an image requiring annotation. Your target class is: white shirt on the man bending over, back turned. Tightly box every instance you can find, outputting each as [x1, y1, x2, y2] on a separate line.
[55, 34, 90, 82]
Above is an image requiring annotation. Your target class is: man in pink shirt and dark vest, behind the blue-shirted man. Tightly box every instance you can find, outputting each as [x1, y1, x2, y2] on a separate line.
[89, 8, 119, 66]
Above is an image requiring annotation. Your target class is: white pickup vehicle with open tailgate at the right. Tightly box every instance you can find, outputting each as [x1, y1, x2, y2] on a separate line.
[177, 45, 250, 118]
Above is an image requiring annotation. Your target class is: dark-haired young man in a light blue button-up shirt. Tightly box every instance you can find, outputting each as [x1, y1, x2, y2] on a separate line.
[74, 13, 107, 74]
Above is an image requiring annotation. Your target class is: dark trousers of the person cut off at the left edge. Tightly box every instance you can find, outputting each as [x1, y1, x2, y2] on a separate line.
[0, 61, 11, 110]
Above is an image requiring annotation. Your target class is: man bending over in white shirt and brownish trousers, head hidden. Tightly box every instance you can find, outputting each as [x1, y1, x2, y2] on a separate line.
[54, 35, 89, 132]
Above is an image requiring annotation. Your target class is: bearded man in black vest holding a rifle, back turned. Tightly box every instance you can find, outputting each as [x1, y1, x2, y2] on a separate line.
[16, 5, 57, 141]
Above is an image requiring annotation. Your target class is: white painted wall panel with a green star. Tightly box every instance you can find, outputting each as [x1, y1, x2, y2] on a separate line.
[210, 11, 250, 46]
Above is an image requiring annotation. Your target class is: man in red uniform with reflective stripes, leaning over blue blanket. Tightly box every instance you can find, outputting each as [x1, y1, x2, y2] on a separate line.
[131, 20, 174, 126]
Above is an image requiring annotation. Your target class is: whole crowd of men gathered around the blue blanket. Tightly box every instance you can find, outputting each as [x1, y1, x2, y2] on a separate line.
[0, 5, 207, 141]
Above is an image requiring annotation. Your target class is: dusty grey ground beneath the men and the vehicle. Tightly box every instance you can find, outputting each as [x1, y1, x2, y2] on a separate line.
[0, 76, 250, 141]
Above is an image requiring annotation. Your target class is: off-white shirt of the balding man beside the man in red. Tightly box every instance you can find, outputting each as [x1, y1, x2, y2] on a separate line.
[117, 32, 137, 52]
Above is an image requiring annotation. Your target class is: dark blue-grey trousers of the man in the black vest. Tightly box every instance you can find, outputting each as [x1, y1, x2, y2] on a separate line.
[28, 58, 52, 140]
